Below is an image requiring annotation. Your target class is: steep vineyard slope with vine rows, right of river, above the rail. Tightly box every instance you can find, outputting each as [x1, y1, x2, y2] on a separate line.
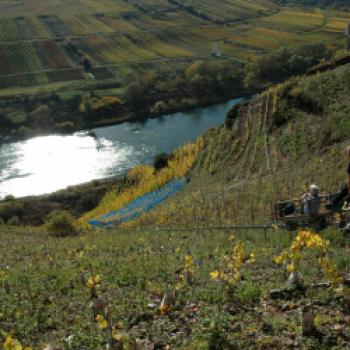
[128, 65, 350, 225]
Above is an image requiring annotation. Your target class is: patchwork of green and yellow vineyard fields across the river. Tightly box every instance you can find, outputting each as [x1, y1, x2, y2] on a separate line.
[0, 0, 350, 89]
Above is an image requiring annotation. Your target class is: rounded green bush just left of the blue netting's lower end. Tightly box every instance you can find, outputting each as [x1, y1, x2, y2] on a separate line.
[45, 210, 77, 236]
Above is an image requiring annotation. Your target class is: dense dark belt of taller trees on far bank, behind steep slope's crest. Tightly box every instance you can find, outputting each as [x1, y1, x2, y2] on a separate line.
[124, 44, 332, 115]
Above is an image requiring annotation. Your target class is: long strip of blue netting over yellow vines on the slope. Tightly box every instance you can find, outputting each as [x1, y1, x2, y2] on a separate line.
[89, 178, 187, 228]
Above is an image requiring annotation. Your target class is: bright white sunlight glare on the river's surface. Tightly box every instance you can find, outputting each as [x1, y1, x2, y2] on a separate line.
[0, 133, 133, 197]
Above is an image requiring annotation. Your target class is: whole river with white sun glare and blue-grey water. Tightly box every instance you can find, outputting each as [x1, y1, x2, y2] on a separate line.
[0, 99, 242, 198]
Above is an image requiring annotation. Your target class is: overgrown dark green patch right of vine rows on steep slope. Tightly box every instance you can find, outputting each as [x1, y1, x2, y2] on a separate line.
[273, 62, 350, 148]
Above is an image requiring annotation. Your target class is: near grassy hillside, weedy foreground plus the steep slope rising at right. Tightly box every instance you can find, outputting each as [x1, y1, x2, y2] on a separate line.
[0, 61, 350, 350]
